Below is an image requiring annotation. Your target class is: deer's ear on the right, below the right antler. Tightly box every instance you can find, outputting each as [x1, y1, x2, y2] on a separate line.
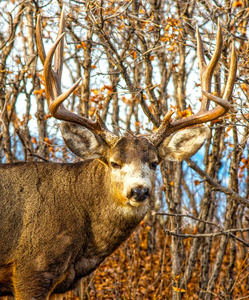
[158, 126, 210, 161]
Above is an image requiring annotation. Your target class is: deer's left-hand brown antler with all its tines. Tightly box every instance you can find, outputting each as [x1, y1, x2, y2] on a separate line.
[36, 8, 119, 145]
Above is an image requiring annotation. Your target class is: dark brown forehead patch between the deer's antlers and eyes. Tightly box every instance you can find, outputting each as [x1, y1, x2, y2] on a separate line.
[111, 137, 157, 163]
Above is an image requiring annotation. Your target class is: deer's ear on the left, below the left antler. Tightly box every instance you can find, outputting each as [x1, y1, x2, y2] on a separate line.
[61, 122, 108, 159]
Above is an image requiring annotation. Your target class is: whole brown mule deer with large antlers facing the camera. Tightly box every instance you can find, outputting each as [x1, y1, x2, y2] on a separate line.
[0, 7, 237, 300]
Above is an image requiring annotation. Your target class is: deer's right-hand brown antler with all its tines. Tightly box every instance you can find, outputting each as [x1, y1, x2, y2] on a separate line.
[150, 23, 237, 146]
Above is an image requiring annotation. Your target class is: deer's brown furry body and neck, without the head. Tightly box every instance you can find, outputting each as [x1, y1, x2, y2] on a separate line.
[0, 139, 154, 300]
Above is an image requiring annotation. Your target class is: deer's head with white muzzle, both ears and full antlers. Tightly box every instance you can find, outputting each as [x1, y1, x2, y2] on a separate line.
[37, 10, 237, 206]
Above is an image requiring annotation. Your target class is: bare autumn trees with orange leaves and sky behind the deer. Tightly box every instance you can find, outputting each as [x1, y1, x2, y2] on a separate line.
[0, 0, 249, 300]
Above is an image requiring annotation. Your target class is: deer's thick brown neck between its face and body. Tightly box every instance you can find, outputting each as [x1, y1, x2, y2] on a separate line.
[76, 160, 149, 256]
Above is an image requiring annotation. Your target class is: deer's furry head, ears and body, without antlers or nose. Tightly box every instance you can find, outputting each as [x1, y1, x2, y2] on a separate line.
[0, 124, 209, 300]
